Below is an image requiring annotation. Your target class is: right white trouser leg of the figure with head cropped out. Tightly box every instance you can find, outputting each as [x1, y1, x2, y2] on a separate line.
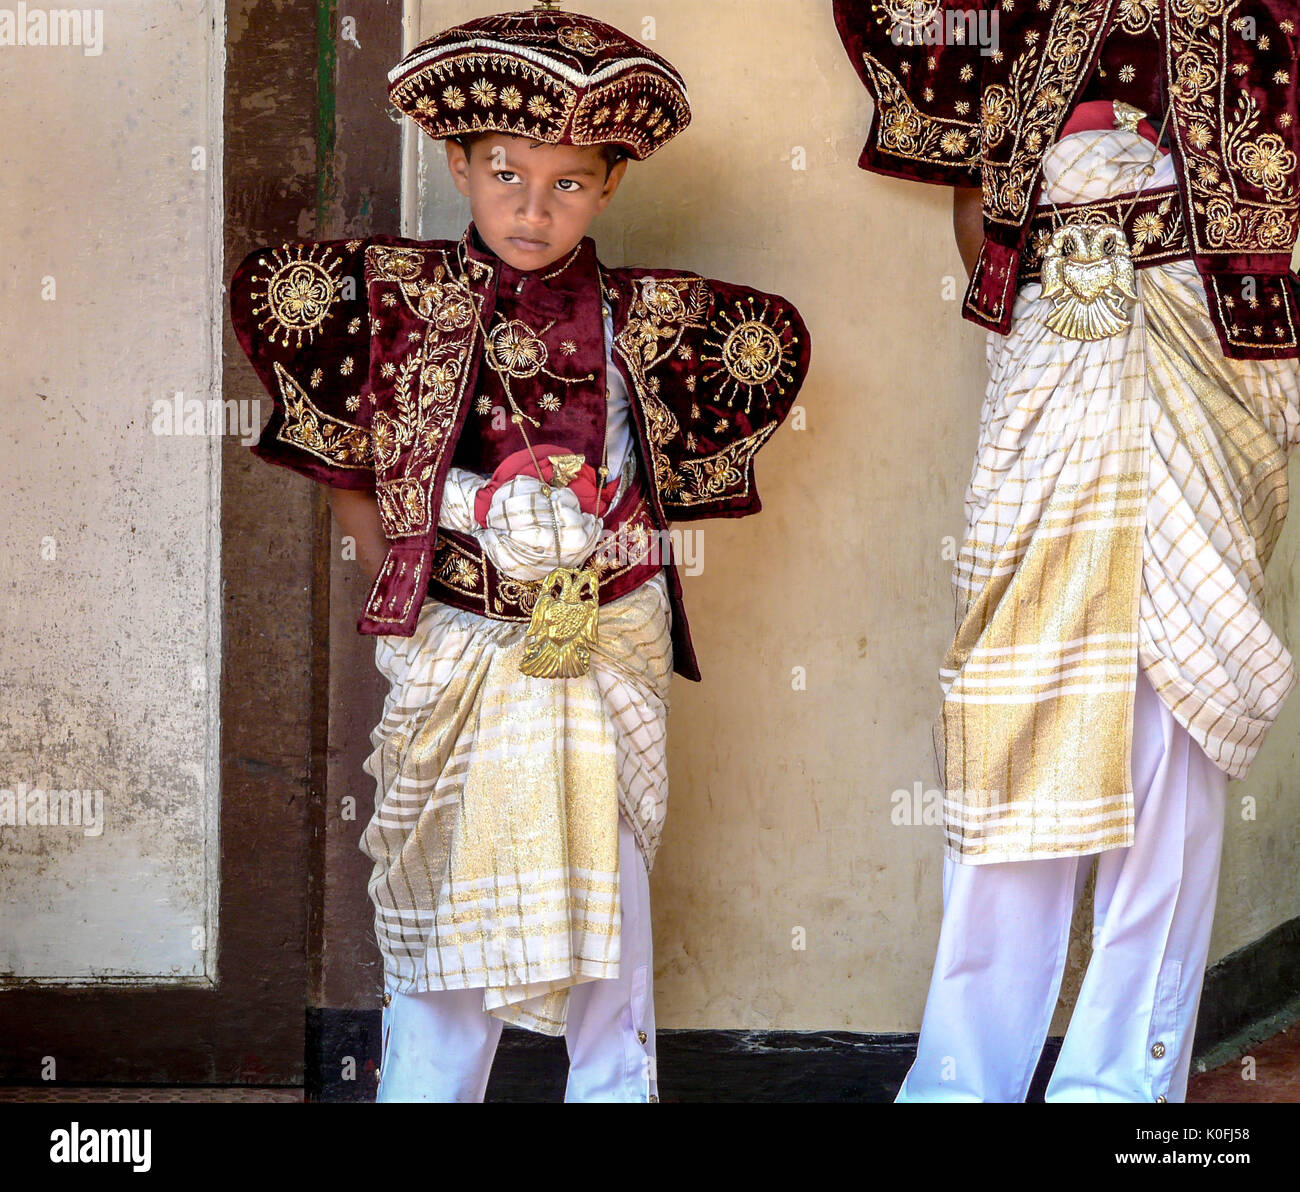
[1047, 675, 1227, 1102]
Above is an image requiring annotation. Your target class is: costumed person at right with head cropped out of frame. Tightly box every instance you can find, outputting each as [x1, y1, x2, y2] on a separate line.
[835, 0, 1300, 1101]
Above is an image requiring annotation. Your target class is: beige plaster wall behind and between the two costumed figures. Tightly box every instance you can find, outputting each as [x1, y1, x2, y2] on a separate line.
[406, 0, 1300, 1031]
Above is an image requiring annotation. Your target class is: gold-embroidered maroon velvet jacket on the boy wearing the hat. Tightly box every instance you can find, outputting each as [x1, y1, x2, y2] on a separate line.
[230, 225, 810, 680]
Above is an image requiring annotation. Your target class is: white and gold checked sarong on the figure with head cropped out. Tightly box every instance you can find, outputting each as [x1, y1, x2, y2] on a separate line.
[936, 131, 1300, 864]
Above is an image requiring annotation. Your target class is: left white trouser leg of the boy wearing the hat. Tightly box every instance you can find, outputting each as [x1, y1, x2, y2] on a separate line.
[374, 989, 502, 1102]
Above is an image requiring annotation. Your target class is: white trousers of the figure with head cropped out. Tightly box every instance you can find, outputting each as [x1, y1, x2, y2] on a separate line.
[897, 672, 1227, 1102]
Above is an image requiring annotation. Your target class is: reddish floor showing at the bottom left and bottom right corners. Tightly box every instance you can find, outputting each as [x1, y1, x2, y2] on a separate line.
[0, 1023, 1300, 1104]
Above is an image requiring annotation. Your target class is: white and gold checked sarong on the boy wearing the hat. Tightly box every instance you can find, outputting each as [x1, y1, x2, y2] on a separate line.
[360, 572, 672, 1035]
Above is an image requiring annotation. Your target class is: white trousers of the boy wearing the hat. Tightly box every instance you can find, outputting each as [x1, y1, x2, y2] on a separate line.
[376, 815, 659, 1102]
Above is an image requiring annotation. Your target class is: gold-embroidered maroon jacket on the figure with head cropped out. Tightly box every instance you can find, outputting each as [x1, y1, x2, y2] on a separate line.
[835, 0, 1300, 359]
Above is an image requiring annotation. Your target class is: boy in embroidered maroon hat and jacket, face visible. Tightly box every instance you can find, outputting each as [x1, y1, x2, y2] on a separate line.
[230, 6, 809, 1101]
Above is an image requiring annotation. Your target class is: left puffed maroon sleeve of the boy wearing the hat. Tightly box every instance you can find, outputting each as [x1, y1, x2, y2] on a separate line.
[230, 240, 374, 489]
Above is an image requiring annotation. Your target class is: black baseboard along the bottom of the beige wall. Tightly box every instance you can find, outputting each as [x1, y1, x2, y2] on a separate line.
[307, 919, 1300, 1102]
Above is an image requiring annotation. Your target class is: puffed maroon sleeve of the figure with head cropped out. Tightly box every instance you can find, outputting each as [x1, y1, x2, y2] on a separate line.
[835, 0, 977, 186]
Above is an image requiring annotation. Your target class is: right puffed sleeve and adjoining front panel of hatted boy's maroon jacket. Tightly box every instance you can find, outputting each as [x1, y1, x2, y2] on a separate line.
[615, 270, 811, 521]
